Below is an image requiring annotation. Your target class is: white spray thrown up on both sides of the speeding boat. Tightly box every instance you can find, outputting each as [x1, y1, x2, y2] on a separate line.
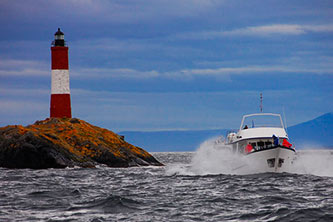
[166, 138, 333, 177]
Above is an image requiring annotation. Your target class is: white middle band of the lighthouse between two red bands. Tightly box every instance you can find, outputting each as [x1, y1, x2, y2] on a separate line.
[51, 69, 70, 94]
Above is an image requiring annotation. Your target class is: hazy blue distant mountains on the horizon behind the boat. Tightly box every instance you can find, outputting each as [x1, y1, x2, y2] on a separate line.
[118, 112, 333, 152]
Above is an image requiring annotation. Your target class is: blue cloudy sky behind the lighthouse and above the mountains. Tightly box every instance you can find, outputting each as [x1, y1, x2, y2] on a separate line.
[0, 0, 333, 132]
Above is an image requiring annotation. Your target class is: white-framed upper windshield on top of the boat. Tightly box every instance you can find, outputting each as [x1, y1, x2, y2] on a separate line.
[240, 113, 284, 129]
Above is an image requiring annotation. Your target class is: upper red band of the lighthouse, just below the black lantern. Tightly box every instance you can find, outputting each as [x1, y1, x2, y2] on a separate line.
[51, 46, 68, 69]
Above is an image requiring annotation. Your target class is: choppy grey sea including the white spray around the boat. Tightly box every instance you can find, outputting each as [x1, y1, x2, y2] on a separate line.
[0, 143, 333, 222]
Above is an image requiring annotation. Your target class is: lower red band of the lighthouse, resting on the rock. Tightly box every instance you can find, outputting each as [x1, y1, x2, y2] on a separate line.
[50, 94, 72, 118]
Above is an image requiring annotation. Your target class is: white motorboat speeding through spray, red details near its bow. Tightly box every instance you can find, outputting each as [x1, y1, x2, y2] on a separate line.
[225, 113, 296, 173]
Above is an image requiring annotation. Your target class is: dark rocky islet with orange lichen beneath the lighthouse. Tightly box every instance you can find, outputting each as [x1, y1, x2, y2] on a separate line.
[0, 118, 162, 169]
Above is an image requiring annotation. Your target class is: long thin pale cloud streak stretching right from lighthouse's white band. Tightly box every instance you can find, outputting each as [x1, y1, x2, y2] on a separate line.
[71, 64, 333, 81]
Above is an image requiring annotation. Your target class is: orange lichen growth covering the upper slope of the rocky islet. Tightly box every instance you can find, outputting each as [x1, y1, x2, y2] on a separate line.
[2, 118, 150, 160]
